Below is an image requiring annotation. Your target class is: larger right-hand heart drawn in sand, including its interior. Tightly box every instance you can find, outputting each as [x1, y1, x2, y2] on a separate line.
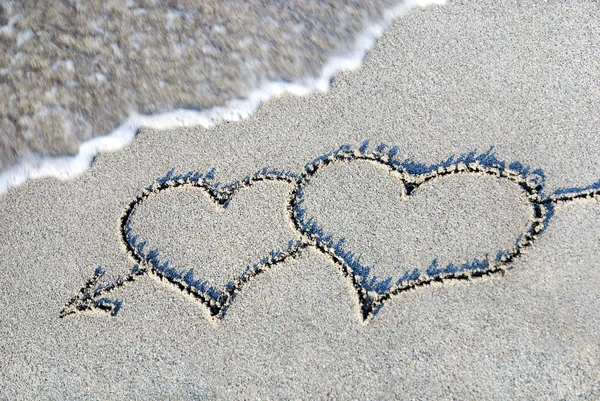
[292, 148, 549, 319]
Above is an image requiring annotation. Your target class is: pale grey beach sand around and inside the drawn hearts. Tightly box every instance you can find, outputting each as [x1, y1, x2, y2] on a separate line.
[0, 1, 600, 399]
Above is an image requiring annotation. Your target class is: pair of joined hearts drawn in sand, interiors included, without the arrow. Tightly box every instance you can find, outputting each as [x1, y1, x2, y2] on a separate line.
[122, 142, 551, 320]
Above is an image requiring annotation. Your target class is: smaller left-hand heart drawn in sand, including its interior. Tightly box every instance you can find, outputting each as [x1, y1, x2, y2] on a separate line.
[123, 171, 301, 316]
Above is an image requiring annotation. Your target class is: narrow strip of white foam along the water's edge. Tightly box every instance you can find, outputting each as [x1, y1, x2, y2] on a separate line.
[0, 0, 446, 195]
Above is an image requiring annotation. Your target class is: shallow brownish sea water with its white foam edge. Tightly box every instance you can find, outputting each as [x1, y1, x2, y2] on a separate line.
[0, 0, 441, 194]
